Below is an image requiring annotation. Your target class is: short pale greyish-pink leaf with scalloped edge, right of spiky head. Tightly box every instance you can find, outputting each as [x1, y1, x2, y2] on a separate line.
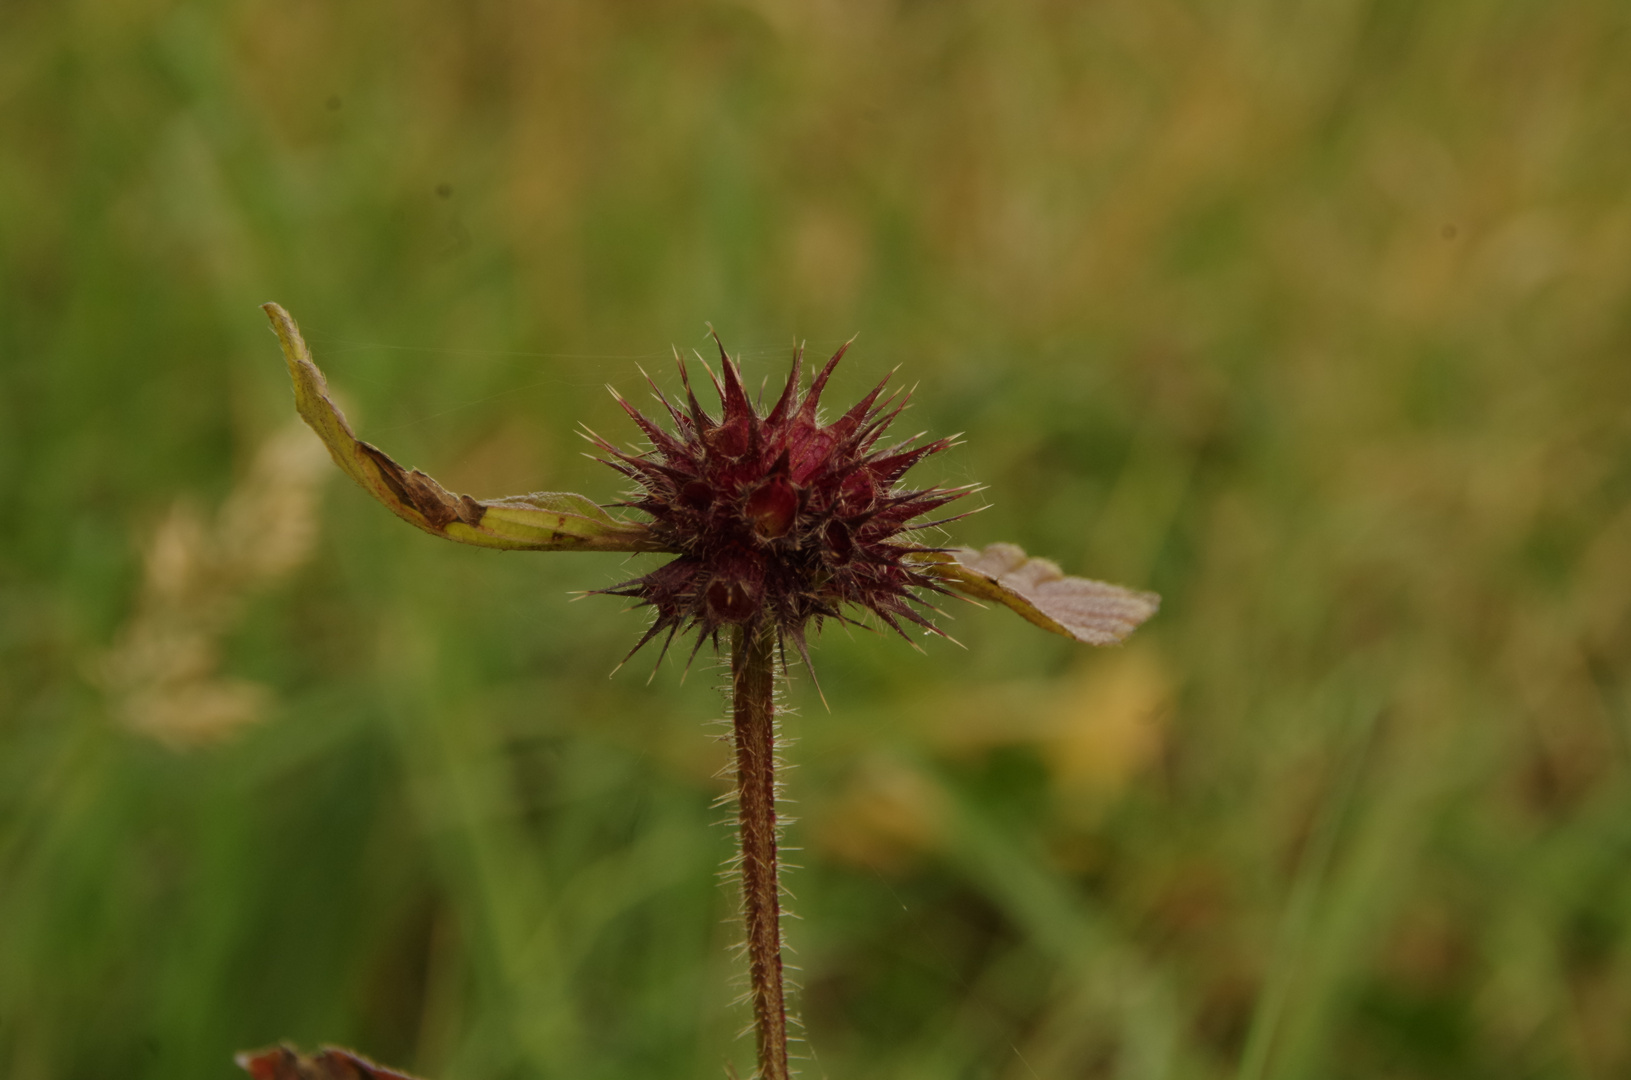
[915, 543, 1161, 644]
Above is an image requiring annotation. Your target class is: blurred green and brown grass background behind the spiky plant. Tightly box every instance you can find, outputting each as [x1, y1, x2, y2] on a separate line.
[0, 0, 1631, 1080]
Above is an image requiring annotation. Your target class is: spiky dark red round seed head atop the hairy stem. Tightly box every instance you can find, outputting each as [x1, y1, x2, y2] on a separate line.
[590, 346, 970, 668]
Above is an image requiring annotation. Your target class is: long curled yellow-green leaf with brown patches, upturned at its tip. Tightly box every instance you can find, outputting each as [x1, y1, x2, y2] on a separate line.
[261, 303, 664, 551]
